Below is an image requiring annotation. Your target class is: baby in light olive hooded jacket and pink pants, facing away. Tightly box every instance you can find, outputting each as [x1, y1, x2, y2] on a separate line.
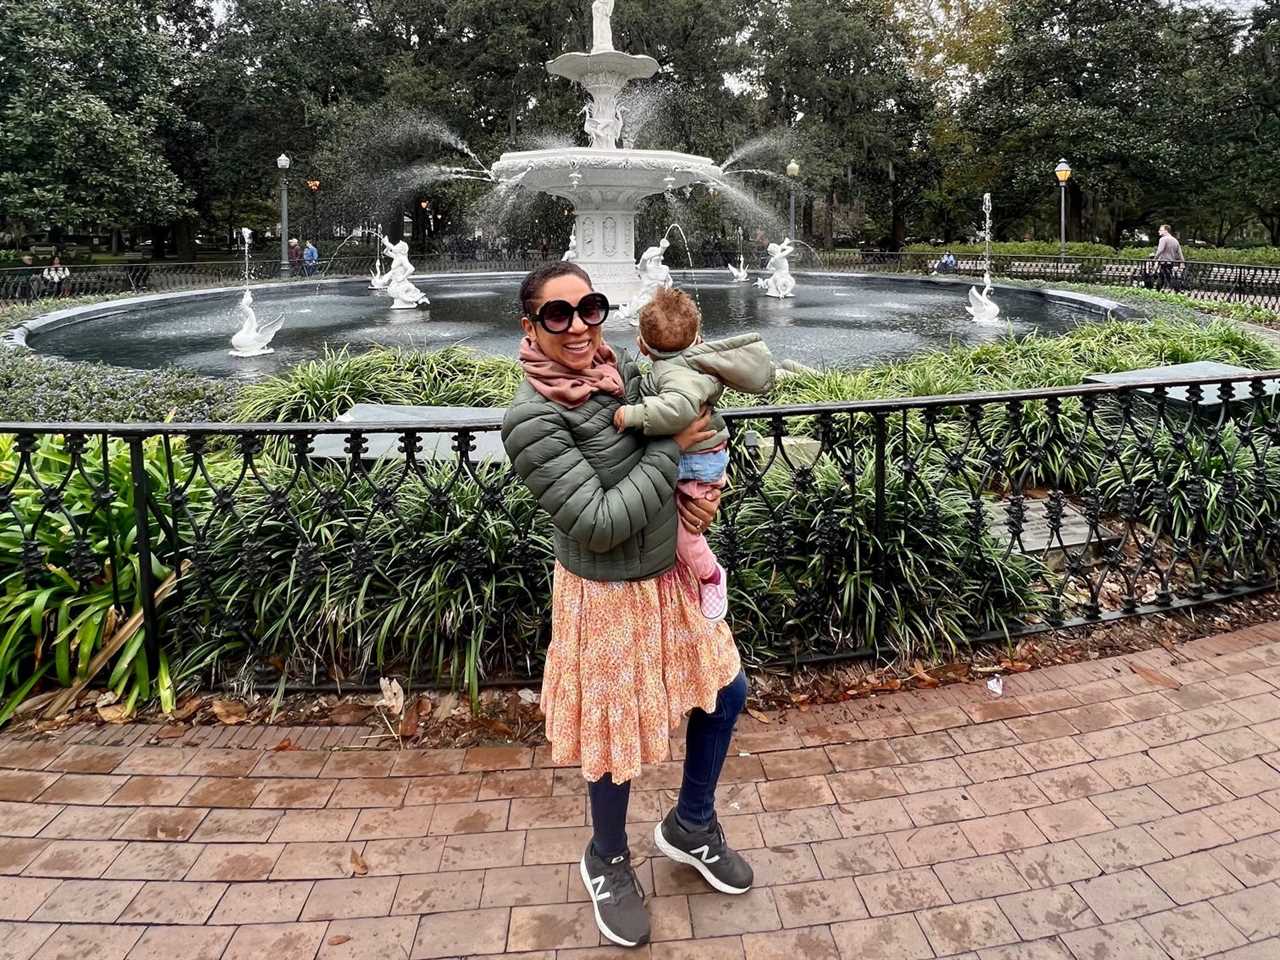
[613, 288, 804, 620]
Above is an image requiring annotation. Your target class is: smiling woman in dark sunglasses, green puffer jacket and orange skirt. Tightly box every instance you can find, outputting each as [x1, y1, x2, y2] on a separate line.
[502, 261, 753, 946]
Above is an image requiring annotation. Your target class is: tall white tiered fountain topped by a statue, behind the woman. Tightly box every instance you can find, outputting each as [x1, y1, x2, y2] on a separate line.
[493, 0, 723, 306]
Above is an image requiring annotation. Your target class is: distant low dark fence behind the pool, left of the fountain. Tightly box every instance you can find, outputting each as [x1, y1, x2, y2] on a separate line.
[0, 253, 555, 303]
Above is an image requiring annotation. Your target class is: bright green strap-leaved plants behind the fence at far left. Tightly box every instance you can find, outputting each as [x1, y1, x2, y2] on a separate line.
[0, 435, 226, 723]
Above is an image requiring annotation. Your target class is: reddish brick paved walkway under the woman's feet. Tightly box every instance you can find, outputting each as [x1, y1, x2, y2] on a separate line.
[0, 625, 1280, 960]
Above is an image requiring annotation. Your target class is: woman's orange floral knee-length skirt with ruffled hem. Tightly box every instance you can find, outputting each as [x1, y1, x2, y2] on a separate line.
[541, 563, 742, 783]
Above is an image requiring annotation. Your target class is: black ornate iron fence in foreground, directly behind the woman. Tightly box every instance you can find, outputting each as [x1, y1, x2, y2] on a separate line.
[0, 371, 1280, 695]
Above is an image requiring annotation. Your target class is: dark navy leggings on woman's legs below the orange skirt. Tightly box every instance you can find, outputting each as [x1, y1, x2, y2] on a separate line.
[586, 671, 748, 859]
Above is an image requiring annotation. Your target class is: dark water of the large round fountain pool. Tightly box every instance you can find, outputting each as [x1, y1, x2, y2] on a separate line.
[17, 270, 1115, 380]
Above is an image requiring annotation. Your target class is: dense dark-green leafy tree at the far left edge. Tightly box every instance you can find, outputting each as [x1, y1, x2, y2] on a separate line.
[0, 0, 188, 229]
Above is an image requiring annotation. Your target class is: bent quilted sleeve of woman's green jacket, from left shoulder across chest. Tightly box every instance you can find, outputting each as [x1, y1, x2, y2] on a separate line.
[502, 402, 680, 553]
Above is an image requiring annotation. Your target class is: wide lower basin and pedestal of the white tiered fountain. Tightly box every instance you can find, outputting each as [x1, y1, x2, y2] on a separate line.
[493, 147, 723, 307]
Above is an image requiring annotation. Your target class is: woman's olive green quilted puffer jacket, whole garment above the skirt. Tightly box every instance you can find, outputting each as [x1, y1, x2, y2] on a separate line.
[502, 355, 680, 581]
